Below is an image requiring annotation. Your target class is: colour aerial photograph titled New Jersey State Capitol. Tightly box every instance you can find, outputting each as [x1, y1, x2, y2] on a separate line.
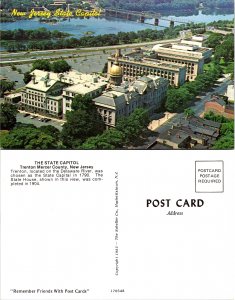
[0, 0, 234, 150]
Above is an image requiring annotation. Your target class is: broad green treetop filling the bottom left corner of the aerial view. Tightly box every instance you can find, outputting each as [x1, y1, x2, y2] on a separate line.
[2, 126, 58, 150]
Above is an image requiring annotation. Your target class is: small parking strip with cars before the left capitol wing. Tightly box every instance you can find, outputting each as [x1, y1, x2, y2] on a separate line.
[16, 111, 64, 131]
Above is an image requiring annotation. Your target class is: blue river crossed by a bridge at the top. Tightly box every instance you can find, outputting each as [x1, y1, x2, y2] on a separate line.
[0, 11, 234, 38]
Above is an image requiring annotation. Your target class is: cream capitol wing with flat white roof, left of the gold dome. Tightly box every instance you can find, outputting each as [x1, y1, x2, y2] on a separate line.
[20, 70, 107, 118]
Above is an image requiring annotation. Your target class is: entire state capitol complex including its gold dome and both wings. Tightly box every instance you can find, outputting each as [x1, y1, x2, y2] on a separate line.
[19, 59, 168, 127]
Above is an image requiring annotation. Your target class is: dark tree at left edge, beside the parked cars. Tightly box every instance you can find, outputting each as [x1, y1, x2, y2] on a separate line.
[0, 103, 17, 130]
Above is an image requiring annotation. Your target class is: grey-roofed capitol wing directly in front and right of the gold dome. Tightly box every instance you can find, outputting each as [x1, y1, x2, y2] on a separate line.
[93, 75, 169, 127]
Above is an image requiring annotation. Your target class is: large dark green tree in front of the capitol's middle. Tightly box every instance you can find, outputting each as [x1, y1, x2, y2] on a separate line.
[61, 95, 105, 149]
